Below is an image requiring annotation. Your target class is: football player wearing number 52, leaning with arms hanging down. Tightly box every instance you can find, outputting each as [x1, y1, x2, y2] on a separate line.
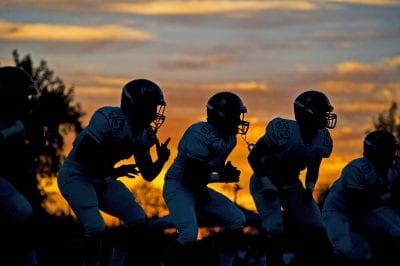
[248, 90, 336, 266]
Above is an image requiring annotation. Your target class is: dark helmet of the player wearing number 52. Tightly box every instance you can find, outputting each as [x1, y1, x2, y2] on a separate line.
[294, 90, 337, 129]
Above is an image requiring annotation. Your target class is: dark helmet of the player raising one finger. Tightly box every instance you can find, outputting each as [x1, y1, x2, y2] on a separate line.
[121, 79, 166, 130]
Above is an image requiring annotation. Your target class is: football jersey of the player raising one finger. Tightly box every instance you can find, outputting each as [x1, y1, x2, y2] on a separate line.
[66, 106, 156, 171]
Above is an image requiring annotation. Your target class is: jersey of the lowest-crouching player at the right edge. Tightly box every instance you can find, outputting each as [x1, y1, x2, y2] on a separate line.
[325, 157, 389, 211]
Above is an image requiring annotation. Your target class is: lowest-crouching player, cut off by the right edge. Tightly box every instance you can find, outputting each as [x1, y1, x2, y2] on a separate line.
[322, 130, 400, 265]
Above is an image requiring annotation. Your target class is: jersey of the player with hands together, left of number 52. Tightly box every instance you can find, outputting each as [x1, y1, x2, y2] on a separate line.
[166, 122, 236, 179]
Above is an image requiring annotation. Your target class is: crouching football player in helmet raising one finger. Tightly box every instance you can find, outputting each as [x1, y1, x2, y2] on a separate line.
[58, 79, 170, 266]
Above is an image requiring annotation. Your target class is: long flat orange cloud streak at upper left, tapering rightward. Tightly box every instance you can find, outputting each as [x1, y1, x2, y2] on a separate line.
[0, 20, 156, 42]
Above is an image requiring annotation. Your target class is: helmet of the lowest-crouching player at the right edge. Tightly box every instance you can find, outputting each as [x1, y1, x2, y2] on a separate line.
[363, 129, 400, 168]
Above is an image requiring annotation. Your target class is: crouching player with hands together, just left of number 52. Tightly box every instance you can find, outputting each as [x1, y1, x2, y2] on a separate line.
[163, 92, 249, 265]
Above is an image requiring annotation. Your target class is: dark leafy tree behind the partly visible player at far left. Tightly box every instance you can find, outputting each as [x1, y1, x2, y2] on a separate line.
[13, 50, 84, 215]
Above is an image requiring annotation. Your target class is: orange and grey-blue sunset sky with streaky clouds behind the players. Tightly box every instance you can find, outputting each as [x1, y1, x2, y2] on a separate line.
[0, 0, 400, 212]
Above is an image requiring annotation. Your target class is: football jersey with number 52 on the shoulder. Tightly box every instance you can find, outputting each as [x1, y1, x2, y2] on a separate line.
[262, 117, 333, 184]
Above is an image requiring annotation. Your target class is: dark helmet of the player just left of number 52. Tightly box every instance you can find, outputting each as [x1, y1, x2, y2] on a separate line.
[207, 91, 250, 135]
